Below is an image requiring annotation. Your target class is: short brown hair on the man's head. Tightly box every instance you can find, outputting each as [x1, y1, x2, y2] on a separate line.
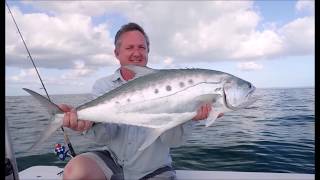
[114, 22, 150, 52]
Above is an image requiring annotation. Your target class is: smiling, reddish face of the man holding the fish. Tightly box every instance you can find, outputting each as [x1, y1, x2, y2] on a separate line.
[114, 31, 148, 66]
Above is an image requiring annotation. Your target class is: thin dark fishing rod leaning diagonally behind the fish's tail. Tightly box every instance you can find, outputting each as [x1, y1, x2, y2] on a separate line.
[5, 1, 76, 157]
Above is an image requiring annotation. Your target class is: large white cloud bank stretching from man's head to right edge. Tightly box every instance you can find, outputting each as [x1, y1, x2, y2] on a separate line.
[119, 1, 314, 63]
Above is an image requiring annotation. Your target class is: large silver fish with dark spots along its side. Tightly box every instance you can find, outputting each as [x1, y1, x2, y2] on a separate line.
[24, 65, 255, 150]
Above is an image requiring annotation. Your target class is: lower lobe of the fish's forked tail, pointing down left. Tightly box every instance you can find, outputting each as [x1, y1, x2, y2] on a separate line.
[26, 116, 63, 151]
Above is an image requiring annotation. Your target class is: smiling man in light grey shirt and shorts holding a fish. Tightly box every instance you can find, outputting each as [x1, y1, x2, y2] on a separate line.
[60, 23, 221, 179]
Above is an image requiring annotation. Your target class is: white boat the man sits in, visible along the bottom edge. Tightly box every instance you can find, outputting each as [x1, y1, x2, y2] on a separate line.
[5, 119, 315, 180]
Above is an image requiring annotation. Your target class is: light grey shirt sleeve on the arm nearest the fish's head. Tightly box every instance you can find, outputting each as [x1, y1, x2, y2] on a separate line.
[160, 120, 195, 147]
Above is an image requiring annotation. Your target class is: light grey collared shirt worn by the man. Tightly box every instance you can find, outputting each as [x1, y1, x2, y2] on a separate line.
[85, 69, 194, 179]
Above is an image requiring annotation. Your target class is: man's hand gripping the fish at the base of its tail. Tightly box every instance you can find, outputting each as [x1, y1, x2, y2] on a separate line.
[59, 104, 93, 132]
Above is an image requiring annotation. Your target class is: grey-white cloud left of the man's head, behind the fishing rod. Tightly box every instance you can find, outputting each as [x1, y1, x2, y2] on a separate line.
[5, 4, 115, 69]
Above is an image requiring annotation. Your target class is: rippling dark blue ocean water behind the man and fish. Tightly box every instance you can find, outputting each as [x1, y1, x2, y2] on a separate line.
[5, 88, 315, 174]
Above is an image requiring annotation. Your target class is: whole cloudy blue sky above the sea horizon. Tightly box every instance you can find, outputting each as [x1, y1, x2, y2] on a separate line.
[5, 0, 315, 96]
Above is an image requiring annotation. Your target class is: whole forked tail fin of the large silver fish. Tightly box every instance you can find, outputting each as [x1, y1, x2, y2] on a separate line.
[23, 88, 64, 151]
